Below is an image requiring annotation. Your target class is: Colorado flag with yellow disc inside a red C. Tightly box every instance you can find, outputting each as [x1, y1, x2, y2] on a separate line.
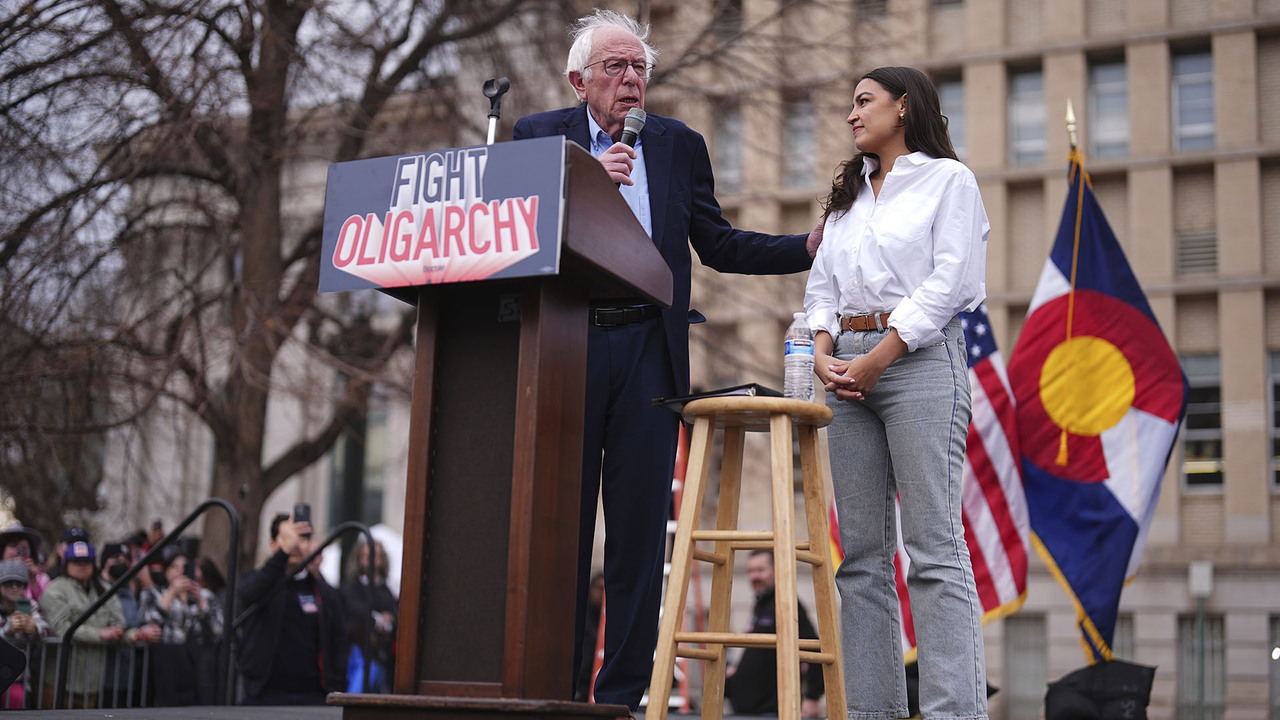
[1009, 150, 1187, 662]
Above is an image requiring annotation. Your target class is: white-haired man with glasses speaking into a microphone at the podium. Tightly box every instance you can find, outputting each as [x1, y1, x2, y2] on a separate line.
[515, 10, 822, 708]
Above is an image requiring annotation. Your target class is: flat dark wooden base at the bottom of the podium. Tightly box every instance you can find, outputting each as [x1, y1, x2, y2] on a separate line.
[328, 693, 630, 720]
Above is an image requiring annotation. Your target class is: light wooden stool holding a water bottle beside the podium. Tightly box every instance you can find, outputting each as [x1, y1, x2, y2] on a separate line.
[645, 397, 847, 720]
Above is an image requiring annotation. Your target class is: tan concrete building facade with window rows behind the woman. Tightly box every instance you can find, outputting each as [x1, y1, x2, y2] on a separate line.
[634, 0, 1280, 720]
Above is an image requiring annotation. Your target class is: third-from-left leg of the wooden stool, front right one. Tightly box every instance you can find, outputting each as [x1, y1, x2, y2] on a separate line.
[769, 414, 800, 720]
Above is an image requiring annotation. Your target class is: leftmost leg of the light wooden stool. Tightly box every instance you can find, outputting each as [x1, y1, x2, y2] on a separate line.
[645, 415, 716, 720]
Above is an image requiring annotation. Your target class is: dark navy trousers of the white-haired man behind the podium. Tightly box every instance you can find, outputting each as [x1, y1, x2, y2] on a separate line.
[573, 318, 678, 707]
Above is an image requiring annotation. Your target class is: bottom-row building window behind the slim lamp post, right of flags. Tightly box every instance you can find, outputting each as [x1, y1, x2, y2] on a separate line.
[1178, 615, 1226, 720]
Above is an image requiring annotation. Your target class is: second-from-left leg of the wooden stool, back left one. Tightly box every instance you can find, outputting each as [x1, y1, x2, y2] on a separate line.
[703, 428, 746, 720]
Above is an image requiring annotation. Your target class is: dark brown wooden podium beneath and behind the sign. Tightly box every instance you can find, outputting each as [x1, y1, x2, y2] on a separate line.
[329, 141, 672, 720]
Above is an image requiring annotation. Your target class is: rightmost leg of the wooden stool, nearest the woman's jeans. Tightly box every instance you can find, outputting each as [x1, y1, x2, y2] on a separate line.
[800, 425, 849, 720]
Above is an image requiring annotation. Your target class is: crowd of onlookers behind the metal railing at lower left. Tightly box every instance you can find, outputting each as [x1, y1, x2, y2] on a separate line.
[0, 515, 397, 710]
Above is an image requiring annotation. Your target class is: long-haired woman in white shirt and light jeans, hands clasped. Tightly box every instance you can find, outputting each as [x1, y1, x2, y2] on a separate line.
[805, 68, 991, 720]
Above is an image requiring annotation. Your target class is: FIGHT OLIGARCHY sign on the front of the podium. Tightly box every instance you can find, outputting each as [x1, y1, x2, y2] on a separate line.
[320, 137, 564, 292]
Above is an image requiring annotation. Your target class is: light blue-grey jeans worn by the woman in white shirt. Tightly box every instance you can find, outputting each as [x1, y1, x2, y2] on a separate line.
[827, 320, 987, 720]
